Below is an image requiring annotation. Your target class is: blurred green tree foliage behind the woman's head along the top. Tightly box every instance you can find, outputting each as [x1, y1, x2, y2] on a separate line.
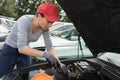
[0, 0, 70, 22]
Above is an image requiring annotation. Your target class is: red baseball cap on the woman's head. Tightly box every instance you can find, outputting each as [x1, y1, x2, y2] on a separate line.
[37, 2, 60, 22]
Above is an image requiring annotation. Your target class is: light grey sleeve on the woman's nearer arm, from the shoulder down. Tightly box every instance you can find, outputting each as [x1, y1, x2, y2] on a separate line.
[17, 17, 29, 51]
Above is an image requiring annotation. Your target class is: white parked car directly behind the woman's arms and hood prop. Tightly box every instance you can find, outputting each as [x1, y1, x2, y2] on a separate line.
[29, 22, 93, 63]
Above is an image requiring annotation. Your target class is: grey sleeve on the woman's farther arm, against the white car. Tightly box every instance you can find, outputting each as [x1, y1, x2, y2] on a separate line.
[43, 30, 53, 51]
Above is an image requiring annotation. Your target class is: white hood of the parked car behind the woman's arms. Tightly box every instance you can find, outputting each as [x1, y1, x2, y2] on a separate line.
[29, 35, 77, 48]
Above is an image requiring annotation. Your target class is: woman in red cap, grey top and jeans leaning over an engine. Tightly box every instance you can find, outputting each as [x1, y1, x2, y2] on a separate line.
[0, 2, 60, 77]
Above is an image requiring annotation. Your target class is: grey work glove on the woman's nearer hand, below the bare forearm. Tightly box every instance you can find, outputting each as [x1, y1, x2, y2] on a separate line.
[43, 52, 58, 67]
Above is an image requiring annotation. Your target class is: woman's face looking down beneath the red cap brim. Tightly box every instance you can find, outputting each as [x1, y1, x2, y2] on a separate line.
[38, 16, 52, 30]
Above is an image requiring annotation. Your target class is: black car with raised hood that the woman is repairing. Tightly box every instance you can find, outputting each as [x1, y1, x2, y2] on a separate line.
[3, 0, 120, 80]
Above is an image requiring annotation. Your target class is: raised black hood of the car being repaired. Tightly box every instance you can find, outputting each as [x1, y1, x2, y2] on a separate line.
[57, 0, 120, 56]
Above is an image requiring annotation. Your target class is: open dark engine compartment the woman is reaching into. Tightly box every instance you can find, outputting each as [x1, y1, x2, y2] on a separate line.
[3, 58, 120, 80]
